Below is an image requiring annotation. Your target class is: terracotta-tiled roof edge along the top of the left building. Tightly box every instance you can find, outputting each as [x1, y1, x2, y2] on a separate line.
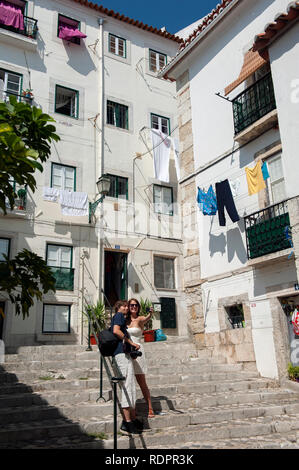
[72, 0, 184, 43]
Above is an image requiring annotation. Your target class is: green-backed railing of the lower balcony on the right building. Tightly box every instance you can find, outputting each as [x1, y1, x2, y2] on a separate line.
[244, 201, 291, 259]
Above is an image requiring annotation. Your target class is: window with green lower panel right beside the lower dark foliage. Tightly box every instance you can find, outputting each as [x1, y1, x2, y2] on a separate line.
[47, 244, 74, 291]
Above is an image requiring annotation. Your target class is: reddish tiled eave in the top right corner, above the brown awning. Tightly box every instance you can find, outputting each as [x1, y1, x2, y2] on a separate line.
[253, 1, 299, 51]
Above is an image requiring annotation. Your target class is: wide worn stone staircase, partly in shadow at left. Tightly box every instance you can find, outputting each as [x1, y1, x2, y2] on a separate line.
[0, 338, 299, 449]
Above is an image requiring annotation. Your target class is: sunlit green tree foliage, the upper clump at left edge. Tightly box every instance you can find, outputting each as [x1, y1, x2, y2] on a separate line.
[0, 96, 60, 214]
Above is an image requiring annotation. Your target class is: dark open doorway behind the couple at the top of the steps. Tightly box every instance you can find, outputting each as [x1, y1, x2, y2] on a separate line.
[104, 250, 128, 306]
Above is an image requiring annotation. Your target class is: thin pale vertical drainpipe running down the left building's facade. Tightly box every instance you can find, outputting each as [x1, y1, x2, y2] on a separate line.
[96, 18, 105, 300]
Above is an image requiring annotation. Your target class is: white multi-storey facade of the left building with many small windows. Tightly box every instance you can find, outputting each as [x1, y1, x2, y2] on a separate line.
[0, 0, 187, 348]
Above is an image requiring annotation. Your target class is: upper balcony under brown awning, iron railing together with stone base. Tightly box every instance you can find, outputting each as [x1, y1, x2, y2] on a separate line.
[233, 72, 277, 144]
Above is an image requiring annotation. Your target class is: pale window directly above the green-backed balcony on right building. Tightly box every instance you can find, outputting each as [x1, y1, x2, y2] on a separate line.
[266, 155, 286, 204]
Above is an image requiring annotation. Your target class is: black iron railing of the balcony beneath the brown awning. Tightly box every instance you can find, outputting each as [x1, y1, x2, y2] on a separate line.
[233, 72, 276, 135]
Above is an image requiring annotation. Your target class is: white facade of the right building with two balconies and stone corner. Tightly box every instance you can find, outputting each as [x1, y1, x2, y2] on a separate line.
[160, 0, 299, 378]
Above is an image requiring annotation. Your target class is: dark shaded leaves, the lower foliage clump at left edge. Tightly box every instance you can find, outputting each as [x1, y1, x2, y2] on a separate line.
[0, 249, 55, 318]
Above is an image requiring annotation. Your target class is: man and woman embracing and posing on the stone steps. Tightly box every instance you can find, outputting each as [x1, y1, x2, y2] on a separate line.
[111, 299, 155, 434]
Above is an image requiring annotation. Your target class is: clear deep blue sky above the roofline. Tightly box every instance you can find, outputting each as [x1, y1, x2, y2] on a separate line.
[92, 0, 220, 34]
